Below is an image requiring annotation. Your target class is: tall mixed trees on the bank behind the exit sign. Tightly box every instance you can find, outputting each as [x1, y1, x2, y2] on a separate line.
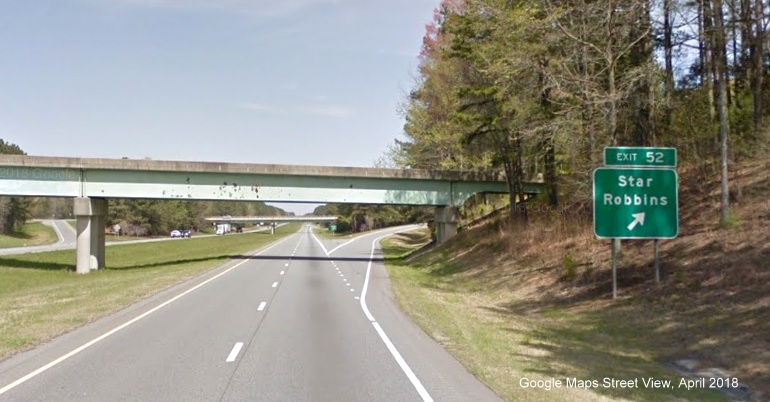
[388, 0, 769, 223]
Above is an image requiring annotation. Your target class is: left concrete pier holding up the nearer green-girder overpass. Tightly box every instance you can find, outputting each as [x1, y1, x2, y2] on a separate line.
[74, 197, 107, 274]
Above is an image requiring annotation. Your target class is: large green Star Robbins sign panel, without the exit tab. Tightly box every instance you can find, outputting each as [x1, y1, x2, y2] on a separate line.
[594, 167, 679, 239]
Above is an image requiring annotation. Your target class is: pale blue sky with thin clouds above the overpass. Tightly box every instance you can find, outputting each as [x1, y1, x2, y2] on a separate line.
[0, 0, 439, 214]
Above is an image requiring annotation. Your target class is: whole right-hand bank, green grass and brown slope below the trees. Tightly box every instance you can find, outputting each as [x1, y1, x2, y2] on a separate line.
[385, 161, 770, 401]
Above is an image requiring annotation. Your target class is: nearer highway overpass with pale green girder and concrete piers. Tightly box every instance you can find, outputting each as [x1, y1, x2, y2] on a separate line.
[0, 155, 545, 273]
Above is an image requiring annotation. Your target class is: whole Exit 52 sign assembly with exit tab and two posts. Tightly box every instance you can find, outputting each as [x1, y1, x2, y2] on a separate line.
[593, 147, 679, 299]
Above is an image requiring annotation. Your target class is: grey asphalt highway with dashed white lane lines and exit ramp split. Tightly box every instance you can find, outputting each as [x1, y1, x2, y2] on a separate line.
[0, 226, 500, 402]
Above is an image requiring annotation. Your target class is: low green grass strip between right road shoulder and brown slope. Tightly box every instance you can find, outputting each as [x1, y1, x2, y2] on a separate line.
[382, 231, 727, 401]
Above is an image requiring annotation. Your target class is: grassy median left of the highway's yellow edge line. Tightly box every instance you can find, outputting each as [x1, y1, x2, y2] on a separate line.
[0, 224, 298, 360]
